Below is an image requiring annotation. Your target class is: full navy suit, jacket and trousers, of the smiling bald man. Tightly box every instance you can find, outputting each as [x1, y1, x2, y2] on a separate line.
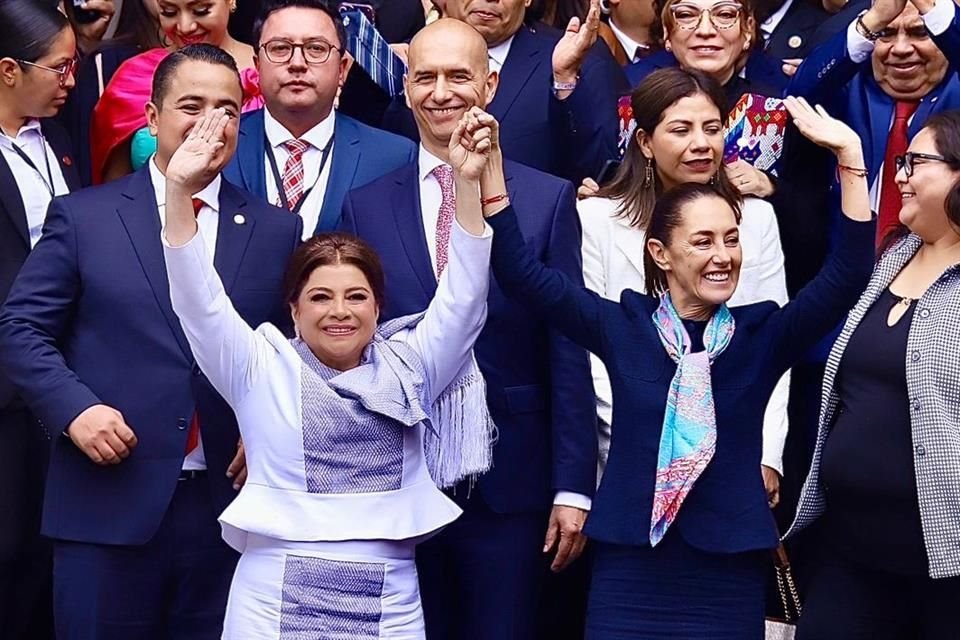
[343, 161, 597, 640]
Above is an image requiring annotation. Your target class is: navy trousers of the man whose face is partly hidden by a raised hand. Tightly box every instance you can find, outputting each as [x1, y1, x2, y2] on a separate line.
[53, 478, 238, 640]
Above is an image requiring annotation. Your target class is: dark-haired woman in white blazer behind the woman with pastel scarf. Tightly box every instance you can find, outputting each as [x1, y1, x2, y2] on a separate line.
[577, 68, 789, 506]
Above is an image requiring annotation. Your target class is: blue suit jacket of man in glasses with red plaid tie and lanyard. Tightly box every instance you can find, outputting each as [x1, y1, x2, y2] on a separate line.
[229, 109, 417, 235]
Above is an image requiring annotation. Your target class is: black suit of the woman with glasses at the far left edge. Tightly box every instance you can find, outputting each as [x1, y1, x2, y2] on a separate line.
[0, 120, 80, 640]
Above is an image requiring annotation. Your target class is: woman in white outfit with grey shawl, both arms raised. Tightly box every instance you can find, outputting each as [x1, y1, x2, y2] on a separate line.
[163, 110, 492, 640]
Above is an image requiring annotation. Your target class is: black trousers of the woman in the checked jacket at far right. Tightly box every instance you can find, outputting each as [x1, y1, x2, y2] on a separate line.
[797, 551, 960, 640]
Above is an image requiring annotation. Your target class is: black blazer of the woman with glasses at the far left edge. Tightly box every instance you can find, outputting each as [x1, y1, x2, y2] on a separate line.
[0, 119, 80, 410]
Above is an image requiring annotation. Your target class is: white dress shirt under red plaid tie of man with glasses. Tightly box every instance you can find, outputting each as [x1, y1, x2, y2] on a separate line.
[263, 107, 336, 240]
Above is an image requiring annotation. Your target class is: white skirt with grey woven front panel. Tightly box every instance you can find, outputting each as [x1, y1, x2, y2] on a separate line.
[223, 534, 425, 640]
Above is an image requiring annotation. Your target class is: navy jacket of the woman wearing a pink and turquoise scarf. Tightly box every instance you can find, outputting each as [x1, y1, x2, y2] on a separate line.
[488, 208, 875, 553]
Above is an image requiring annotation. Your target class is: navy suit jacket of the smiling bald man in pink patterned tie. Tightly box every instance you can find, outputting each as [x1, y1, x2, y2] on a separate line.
[343, 161, 597, 513]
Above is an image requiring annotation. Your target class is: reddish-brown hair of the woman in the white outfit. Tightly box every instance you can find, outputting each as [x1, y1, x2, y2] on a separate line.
[283, 233, 384, 307]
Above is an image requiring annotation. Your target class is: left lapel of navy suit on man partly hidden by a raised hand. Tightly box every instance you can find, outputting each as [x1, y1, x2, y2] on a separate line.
[117, 165, 193, 361]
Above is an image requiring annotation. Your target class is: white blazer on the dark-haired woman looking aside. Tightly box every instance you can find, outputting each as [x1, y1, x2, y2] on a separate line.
[577, 198, 790, 482]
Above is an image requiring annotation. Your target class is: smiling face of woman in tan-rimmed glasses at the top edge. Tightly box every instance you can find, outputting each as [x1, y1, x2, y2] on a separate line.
[663, 0, 754, 84]
